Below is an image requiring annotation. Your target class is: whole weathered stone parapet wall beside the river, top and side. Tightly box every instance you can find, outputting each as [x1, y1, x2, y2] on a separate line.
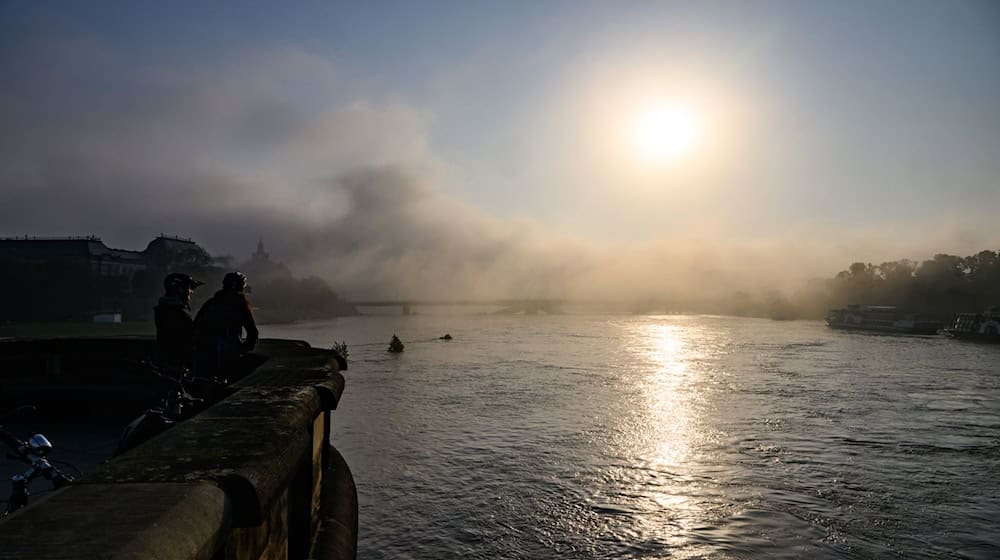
[0, 340, 357, 560]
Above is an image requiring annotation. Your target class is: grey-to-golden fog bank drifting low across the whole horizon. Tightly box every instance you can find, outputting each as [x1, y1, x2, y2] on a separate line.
[0, 41, 1000, 301]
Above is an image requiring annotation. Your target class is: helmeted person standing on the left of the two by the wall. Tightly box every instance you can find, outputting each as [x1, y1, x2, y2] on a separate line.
[153, 272, 204, 368]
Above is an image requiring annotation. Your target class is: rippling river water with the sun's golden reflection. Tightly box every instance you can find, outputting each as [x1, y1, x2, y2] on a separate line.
[262, 307, 1000, 559]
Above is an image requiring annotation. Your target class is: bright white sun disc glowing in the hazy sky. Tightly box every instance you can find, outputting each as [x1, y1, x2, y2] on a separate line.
[629, 105, 701, 164]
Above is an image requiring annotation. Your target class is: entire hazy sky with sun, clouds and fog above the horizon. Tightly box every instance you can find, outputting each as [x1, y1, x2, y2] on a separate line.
[0, 0, 1000, 297]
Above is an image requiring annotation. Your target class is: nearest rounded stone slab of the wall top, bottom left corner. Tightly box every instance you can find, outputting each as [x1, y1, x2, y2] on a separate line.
[0, 483, 230, 560]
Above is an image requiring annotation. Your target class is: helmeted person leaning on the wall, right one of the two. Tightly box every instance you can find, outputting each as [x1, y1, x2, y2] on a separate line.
[194, 272, 266, 380]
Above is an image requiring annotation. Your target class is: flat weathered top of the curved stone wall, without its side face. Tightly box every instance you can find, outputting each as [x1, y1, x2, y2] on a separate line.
[0, 339, 352, 560]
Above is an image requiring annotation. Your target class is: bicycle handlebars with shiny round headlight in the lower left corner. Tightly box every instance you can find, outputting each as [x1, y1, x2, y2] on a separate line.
[0, 406, 76, 517]
